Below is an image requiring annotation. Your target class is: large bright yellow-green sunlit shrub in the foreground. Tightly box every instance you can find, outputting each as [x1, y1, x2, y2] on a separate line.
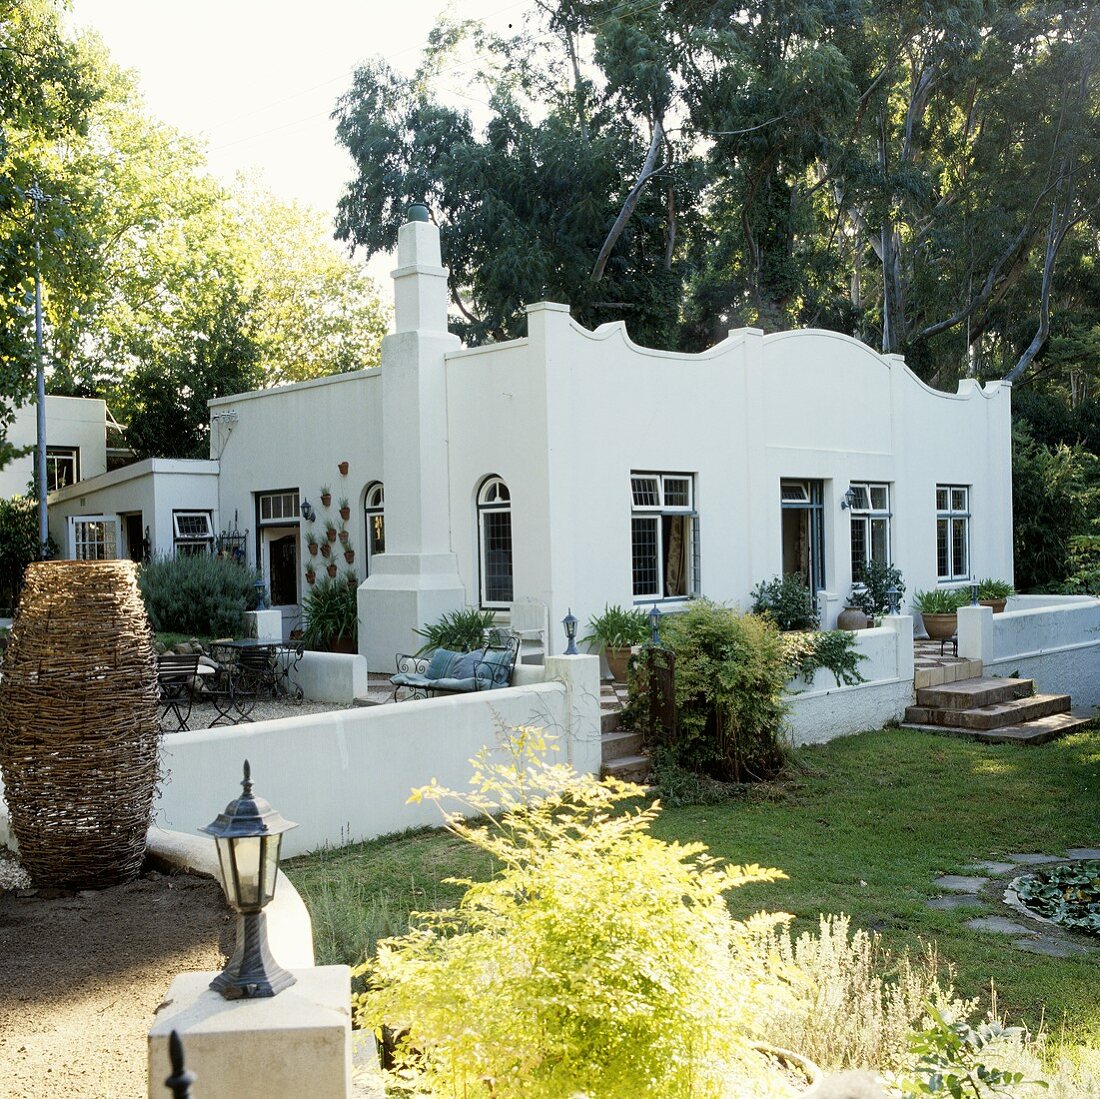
[355, 729, 796, 1099]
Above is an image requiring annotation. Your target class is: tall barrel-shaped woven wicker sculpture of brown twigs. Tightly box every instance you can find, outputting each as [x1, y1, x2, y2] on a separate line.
[0, 561, 160, 889]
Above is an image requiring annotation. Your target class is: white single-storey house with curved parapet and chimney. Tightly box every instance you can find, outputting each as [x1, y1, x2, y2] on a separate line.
[36, 210, 1012, 671]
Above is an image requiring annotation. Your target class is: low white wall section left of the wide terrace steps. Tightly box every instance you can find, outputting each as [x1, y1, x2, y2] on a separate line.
[787, 615, 913, 745]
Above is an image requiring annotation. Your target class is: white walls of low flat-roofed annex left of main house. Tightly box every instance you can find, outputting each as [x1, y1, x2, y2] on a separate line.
[50, 458, 223, 557]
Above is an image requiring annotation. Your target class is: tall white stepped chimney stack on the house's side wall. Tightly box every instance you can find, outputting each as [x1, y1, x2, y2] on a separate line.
[359, 213, 466, 671]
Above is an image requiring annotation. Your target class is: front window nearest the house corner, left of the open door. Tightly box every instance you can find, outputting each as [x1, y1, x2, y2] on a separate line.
[630, 472, 699, 603]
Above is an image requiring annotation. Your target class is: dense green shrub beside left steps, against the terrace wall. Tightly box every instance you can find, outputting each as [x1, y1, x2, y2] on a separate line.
[646, 600, 791, 782]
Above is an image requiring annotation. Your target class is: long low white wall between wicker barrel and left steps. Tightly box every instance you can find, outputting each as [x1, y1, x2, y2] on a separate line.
[154, 656, 601, 856]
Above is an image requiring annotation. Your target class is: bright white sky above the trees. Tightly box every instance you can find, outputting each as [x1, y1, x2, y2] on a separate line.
[69, 0, 532, 224]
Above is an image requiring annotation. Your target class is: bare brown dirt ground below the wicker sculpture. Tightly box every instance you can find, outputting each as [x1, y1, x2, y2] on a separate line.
[0, 871, 228, 1099]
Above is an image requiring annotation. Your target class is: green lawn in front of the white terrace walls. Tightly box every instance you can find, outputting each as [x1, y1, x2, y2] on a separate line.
[285, 729, 1100, 1047]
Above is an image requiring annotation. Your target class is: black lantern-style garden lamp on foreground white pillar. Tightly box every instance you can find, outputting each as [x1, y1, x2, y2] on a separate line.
[199, 760, 297, 1000]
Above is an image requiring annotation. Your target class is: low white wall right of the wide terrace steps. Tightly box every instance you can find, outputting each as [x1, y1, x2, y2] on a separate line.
[958, 595, 1100, 714]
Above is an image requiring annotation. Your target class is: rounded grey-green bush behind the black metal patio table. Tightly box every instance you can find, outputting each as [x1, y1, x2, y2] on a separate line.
[138, 553, 256, 637]
